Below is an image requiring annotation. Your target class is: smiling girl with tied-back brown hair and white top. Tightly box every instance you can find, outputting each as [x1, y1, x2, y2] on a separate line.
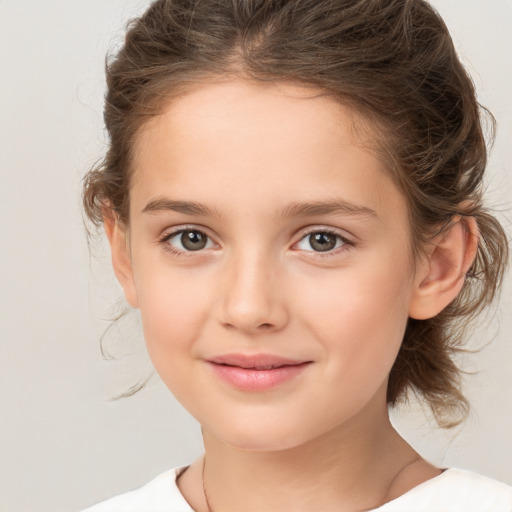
[84, 0, 512, 512]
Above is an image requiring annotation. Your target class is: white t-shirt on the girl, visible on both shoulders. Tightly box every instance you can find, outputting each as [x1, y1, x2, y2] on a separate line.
[82, 468, 512, 512]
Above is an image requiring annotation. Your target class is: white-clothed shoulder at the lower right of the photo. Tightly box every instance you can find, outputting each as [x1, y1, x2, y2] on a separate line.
[375, 468, 512, 512]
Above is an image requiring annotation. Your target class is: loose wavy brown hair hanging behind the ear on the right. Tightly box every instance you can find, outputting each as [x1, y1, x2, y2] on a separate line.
[387, 207, 509, 428]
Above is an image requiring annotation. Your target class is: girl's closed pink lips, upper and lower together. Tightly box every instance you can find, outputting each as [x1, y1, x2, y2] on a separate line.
[207, 354, 312, 392]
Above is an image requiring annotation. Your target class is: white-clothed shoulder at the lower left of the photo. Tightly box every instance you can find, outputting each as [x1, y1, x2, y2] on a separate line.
[82, 468, 192, 512]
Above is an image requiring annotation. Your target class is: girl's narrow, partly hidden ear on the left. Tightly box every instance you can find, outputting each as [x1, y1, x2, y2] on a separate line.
[103, 214, 139, 308]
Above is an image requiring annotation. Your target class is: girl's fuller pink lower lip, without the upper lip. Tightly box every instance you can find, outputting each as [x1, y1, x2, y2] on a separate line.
[208, 362, 310, 392]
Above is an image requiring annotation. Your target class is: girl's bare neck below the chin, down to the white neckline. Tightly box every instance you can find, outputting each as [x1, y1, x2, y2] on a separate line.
[198, 400, 418, 512]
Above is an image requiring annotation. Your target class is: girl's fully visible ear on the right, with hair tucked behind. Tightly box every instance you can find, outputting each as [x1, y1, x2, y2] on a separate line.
[409, 216, 479, 320]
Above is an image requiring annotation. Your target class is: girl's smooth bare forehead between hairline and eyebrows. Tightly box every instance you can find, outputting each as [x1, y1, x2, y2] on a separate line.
[131, 81, 406, 224]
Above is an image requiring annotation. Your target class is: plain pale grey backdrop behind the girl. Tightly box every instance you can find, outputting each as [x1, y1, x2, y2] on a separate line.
[0, 0, 512, 512]
